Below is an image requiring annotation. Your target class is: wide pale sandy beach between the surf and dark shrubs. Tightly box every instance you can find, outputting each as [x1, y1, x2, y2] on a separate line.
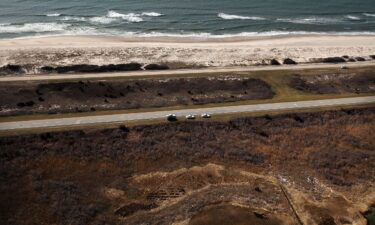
[0, 35, 375, 69]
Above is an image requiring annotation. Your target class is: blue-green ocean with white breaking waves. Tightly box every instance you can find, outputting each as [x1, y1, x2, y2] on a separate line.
[0, 0, 375, 39]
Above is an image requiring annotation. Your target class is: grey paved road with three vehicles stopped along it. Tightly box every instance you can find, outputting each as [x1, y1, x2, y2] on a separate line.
[0, 96, 375, 131]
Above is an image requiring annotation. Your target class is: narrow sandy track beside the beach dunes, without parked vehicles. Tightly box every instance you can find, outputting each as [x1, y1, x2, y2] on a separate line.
[0, 61, 375, 82]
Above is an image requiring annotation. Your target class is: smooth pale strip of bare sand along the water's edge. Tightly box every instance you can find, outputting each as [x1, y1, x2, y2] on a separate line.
[0, 33, 375, 46]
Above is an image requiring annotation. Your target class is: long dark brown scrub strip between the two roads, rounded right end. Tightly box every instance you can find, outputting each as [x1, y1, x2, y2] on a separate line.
[0, 77, 275, 116]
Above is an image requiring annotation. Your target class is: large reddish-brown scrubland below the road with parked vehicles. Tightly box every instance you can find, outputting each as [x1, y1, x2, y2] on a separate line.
[0, 107, 375, 224]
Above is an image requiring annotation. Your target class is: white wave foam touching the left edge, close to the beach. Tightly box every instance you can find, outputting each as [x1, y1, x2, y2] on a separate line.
[0, 23, 70, 33]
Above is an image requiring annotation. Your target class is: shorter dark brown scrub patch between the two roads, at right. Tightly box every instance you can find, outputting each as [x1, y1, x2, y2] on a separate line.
[290, 72, 375, 94]
